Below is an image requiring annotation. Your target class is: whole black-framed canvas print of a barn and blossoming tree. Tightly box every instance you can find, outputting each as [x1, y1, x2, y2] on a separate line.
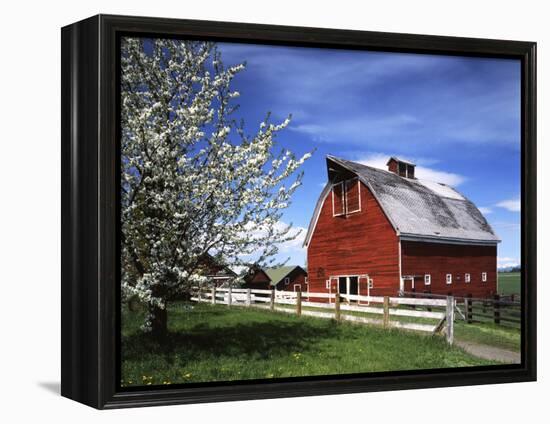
[62, 15, 536, 408]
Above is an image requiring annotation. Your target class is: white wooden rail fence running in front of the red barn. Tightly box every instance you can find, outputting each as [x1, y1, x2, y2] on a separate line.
[191, 287, 455, 344]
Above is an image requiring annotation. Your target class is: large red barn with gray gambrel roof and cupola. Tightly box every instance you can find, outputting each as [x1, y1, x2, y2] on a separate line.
[304, 156, 500, 297]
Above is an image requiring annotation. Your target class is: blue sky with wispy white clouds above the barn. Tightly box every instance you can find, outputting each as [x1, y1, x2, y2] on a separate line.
[218, 43, 521, 266]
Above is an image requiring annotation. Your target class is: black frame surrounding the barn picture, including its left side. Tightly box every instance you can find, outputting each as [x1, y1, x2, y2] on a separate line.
[61, 15, 536, 409]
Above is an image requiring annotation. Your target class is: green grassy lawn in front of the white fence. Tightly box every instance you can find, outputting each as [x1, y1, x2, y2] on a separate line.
[122, 304, 500, 386]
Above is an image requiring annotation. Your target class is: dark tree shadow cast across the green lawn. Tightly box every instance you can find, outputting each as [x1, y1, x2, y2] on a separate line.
[122, 321, 338, 361]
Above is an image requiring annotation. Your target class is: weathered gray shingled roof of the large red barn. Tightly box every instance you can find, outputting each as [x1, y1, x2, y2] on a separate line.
[304, 156, 500, 245]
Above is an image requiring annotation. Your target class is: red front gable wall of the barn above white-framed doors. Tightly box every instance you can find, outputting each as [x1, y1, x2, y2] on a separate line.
[307, 183, 399, 295]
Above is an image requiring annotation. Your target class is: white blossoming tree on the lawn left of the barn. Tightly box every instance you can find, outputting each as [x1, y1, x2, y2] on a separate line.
[121, 38, 310, 338]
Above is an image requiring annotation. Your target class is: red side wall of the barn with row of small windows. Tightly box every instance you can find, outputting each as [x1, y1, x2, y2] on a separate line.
[401, 241, 497, 297]
